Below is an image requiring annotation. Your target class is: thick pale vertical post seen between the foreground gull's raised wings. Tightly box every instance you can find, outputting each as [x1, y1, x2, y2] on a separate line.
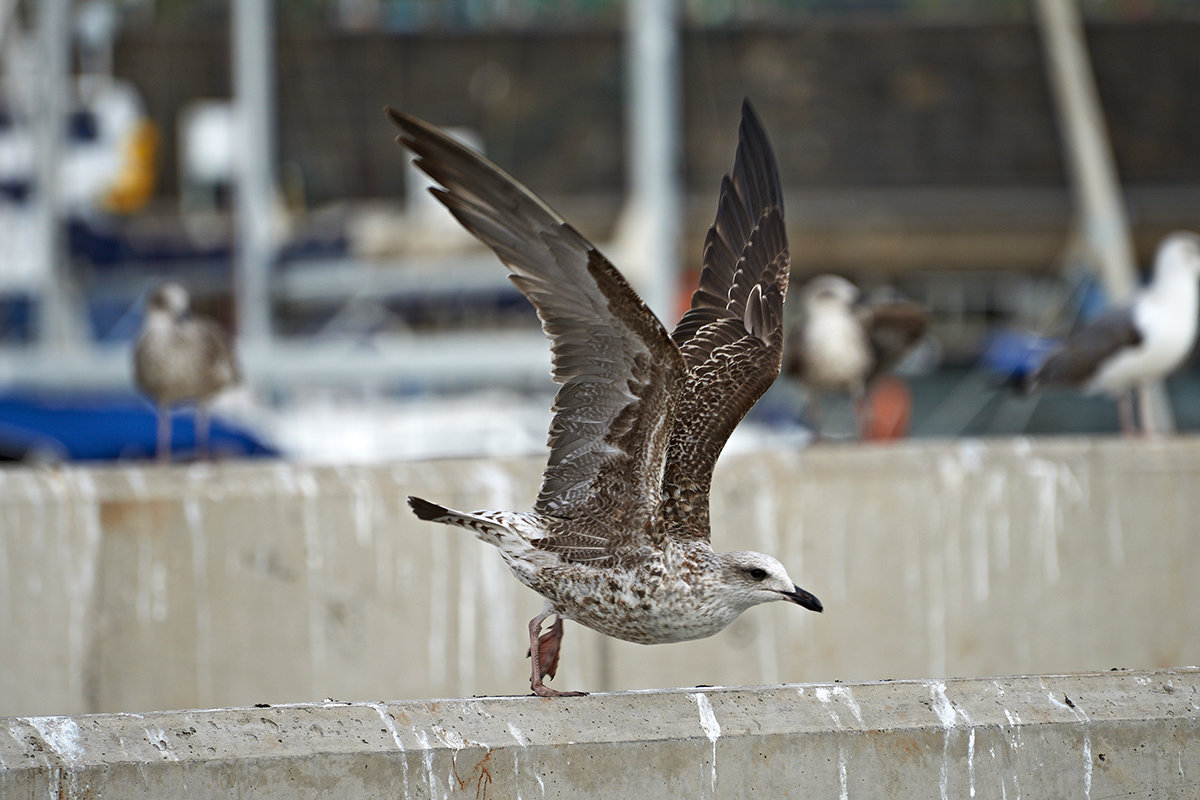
[625, 0, 683, 327]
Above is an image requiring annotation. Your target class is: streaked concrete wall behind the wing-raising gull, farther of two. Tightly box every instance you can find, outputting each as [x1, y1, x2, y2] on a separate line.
[0, 438, 1200, 715]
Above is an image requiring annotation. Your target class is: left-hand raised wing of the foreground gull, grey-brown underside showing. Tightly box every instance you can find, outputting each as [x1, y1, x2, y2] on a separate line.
[386, 108, 684, 561]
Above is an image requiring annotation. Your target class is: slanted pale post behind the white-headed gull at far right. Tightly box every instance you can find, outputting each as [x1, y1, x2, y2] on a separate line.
[1034, 0, 1175, 432]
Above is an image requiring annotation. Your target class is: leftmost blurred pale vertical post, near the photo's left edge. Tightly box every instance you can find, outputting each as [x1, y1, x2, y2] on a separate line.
[32, 0, 79, 350]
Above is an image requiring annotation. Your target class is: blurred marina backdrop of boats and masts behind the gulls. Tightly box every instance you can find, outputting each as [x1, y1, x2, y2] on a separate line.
[0, 0, 1200, 463]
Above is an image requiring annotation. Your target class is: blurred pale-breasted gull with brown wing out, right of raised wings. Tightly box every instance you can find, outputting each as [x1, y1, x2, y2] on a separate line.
[784, 275, 929, 435]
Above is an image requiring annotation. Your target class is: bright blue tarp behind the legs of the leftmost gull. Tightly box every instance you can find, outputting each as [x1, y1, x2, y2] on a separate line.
[0, 393, 278, 461]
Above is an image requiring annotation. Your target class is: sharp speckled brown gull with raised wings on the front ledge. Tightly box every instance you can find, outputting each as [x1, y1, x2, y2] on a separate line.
[386, 103, 821, 697]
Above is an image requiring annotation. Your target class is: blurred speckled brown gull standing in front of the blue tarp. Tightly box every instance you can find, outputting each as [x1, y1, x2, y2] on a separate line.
[133, 281, 240, 462]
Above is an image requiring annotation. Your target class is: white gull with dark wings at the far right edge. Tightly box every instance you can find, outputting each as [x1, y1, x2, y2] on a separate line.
[1024, 231, 1200, 433]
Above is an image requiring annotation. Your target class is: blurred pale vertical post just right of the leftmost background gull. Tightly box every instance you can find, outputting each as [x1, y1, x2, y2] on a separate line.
[233, 0, 275, 350]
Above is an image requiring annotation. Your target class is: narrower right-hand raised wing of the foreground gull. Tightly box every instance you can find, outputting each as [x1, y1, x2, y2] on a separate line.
[661, 102, 791, 539]
